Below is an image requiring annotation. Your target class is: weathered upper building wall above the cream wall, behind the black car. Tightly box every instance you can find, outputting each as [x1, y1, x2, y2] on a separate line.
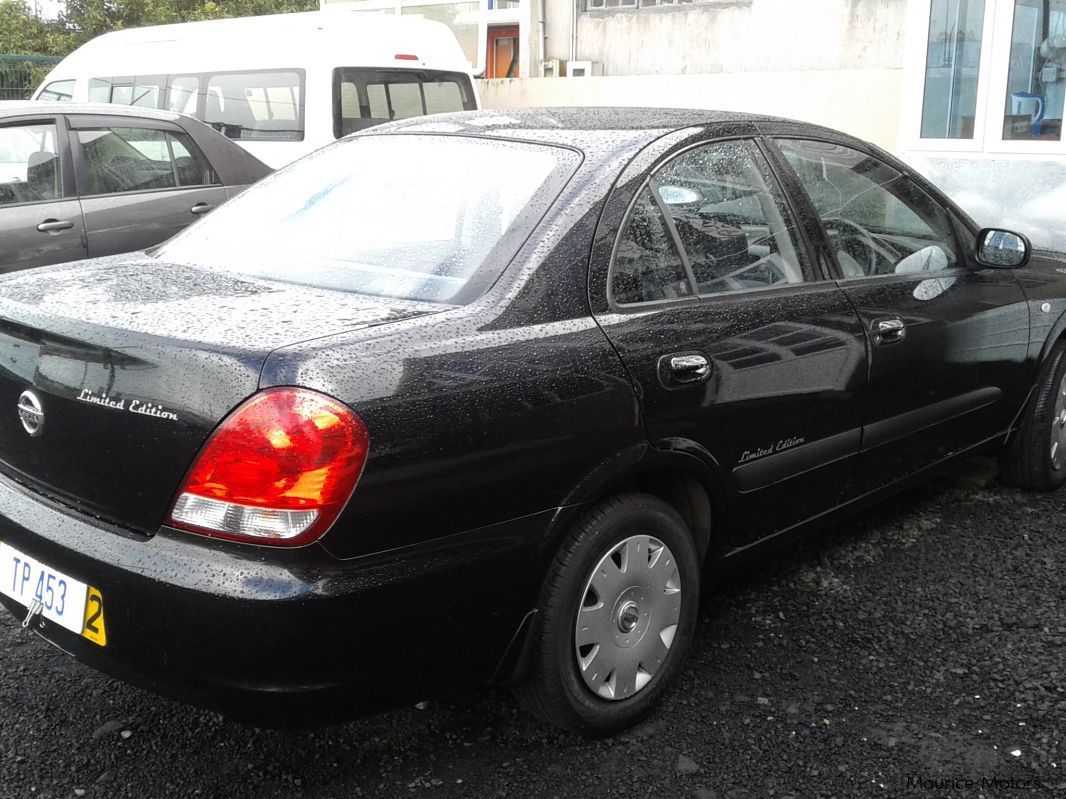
[547, 0, 907, 76]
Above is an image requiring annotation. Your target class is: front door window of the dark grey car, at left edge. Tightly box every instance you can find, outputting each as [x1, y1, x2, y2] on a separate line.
[0, 124, 63, 206]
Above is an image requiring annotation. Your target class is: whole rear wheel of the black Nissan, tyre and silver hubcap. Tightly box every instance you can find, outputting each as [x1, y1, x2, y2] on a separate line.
[515, 493, 699, 737]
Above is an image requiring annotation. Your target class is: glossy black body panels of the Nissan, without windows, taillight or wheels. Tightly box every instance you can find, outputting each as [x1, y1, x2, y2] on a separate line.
[0, 110, 1066, 723]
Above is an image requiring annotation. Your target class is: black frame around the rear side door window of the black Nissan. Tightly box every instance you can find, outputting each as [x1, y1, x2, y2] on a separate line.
[604, 133, 831, 313]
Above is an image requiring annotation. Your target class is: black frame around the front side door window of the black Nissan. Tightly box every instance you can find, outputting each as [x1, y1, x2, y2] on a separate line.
[766, 137, 975, 282]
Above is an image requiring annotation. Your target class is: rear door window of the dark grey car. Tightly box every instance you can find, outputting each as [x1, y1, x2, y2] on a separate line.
[78, 128, 216, 194]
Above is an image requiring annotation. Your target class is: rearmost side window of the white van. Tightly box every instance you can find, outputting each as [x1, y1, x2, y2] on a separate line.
[204, 69, 304, 142]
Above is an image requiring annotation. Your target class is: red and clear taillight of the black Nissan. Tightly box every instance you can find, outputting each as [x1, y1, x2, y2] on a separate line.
[167, 388, 370, 547]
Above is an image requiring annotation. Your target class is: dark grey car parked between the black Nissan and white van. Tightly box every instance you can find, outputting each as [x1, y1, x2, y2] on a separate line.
[0, 101, 271, 272]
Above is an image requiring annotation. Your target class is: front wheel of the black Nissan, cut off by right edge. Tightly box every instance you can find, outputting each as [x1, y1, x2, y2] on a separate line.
[1000, 341, 1066, 491]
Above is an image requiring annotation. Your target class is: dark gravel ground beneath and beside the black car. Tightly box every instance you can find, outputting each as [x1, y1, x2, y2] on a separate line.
[0, 464, 1066, 799]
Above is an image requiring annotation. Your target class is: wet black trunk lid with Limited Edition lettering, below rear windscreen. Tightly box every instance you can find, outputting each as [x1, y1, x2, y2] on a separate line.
[0, 255, 447, 532]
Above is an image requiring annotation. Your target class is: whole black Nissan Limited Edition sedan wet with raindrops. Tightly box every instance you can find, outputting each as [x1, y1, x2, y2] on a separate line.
[0, 109, 1066, 735]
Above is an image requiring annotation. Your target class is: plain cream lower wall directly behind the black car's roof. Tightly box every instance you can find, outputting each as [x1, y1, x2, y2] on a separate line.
[478, 68, 902, 151]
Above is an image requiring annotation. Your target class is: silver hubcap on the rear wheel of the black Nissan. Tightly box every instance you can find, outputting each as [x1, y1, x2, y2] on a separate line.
[574, 536, 681, 700]
